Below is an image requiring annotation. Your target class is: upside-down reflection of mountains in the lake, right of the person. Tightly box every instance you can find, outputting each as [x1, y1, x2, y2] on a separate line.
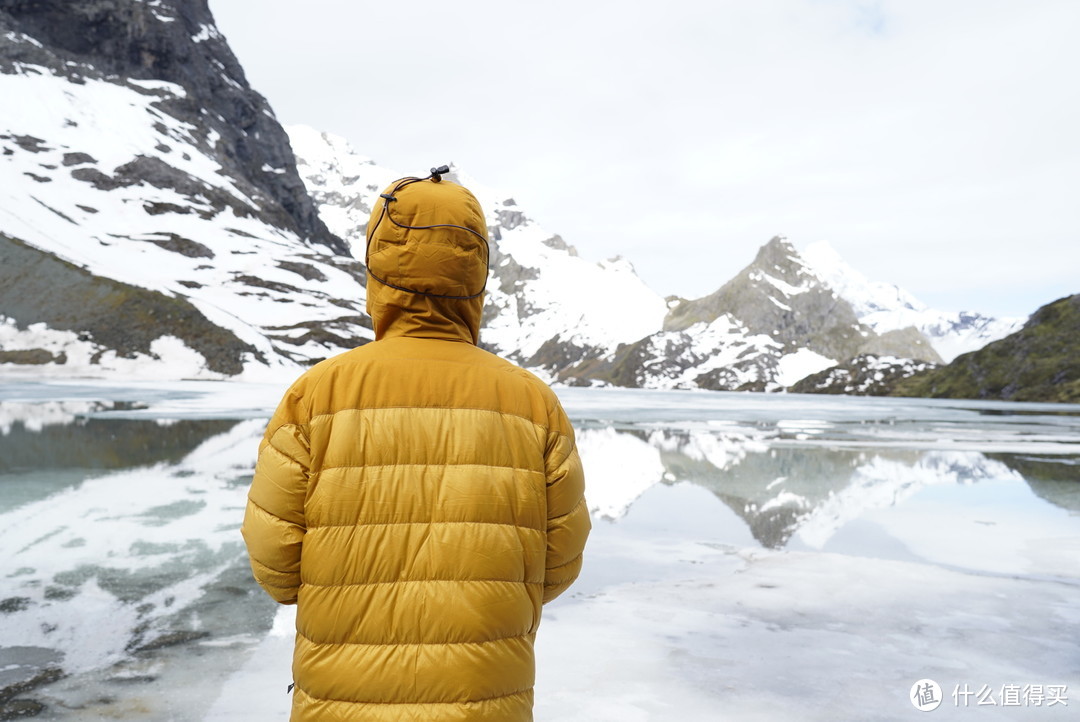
[581, 430, 1080, 548]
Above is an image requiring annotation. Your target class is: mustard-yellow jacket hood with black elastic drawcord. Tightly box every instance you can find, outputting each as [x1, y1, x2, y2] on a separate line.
[365, 178, 488, 344]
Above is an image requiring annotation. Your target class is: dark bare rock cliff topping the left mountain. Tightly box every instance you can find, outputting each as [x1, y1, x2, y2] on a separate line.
[0, 0, 349, 255]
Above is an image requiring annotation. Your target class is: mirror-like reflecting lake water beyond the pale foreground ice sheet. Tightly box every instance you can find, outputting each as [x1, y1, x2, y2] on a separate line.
[0, 382, 1080, 720]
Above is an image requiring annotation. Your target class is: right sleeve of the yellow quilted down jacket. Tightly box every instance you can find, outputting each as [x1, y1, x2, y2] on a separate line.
[543, 422, 592, 603]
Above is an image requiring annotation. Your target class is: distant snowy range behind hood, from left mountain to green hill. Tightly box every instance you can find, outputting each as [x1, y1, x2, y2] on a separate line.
[288, 126, 1008, 391]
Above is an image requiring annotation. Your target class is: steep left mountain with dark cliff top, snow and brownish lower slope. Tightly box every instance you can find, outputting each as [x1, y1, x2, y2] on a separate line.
[0, 0, 370, 378]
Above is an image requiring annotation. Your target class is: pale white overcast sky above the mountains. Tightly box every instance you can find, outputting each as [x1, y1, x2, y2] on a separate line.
[210, 0, 1080, 316]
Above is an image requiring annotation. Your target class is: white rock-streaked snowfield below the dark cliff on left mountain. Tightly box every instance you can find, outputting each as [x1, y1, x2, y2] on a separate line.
[0, 68, 363, 374]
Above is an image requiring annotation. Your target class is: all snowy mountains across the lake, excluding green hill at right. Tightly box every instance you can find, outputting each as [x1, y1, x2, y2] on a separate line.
[0, 0, 1028, 390]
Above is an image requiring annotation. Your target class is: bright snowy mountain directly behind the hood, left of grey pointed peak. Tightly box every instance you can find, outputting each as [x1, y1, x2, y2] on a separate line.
[286, 126, 666, 378]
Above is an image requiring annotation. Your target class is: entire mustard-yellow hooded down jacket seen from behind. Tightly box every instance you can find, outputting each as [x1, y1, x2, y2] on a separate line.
[243, 175, 590, 722]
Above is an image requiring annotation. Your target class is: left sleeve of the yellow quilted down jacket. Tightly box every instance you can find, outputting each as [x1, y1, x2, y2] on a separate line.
[241, 388, 310, 604]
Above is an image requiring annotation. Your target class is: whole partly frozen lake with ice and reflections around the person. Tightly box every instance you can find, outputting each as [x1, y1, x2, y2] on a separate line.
[0, 380, 1080, 722]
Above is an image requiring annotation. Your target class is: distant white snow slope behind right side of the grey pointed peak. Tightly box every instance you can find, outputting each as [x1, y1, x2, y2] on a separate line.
[802, 241, 1025, 363]
